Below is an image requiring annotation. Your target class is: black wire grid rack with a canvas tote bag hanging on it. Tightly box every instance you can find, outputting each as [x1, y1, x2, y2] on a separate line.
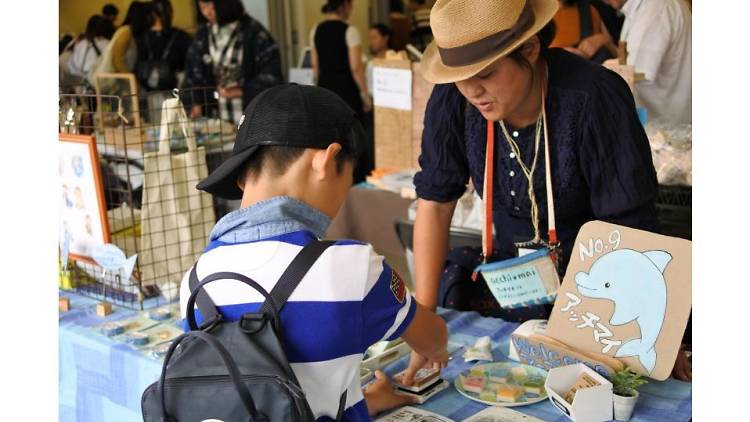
[59, 86, 238, 309]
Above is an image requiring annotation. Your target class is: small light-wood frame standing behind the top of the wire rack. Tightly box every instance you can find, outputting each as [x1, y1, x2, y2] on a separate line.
[95, 73, 141, 127]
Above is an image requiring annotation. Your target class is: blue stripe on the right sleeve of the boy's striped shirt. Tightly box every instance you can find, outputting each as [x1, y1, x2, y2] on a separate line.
[362, 262, 414, 349]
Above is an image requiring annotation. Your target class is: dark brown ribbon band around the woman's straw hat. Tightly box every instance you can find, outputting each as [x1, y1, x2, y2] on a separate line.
[437, 0, 534, 67]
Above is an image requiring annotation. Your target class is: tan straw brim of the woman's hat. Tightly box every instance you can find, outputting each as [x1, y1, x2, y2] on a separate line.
[419, 0, 560, 84]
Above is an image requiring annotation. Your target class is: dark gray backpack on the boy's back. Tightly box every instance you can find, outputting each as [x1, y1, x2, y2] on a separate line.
[141, 241, 346, 422]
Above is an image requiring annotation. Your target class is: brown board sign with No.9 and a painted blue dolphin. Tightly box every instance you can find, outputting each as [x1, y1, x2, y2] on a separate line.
[546, 221, 692, 380]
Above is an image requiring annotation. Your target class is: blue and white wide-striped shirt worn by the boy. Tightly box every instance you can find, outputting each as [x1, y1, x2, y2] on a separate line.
[180, 230, 416, 421]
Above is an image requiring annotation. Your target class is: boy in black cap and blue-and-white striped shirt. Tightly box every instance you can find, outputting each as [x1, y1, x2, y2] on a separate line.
[180, 84, 448, 421]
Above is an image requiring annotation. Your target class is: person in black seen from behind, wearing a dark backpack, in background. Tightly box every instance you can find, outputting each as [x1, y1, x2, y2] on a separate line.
[135, 0, 192, 91]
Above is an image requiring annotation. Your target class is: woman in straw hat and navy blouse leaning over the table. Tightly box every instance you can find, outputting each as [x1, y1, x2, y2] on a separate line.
[407, 0, 684, 378]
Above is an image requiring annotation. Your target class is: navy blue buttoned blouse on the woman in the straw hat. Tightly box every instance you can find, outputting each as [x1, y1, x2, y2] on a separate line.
[414, 49, 658, 268]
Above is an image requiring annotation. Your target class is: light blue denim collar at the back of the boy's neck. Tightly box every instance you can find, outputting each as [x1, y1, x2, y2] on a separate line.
[209, 196, 331, 243]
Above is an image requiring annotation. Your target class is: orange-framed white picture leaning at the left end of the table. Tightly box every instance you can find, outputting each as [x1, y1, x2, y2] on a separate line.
[58, 133, 110, 262]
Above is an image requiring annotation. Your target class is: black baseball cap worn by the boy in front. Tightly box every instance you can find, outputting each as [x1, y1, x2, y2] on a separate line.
[196, 84, 364, 199]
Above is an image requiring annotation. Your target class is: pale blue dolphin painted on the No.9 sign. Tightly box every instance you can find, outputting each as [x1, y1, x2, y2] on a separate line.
[575, 249, 672, 374]
